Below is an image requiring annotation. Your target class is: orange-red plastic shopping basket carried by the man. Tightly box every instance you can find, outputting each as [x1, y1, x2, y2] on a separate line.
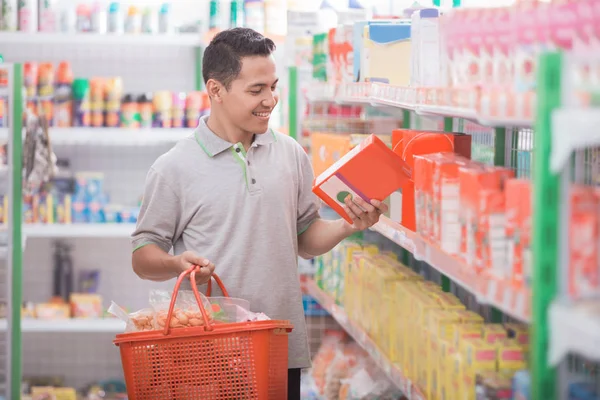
[114, 267, 292, 400]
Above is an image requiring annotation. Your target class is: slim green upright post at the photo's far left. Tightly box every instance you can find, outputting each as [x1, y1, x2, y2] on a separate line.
[9, 64, 23, 400]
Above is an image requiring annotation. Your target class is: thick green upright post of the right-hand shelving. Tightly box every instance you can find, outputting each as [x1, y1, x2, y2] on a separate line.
[530, 53, 562, 400]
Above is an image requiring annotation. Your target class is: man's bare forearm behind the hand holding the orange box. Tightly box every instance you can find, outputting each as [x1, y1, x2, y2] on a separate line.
[298, 219, 356, 258]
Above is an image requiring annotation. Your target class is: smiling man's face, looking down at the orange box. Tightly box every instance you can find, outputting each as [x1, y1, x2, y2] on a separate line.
[222, 56, 279, 134]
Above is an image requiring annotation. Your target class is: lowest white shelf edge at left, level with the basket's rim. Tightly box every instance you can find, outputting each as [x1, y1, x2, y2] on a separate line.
[0, 318, 125, 333]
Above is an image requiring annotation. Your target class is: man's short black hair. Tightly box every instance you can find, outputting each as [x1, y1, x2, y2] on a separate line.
[202, 28, 275, 89]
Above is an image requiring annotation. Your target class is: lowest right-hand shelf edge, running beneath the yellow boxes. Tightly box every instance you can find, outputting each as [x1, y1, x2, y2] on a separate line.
[307, 280, 425, 400]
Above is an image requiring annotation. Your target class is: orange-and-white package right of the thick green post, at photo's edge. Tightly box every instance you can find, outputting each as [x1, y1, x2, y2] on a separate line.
[568, 185, 600, 300]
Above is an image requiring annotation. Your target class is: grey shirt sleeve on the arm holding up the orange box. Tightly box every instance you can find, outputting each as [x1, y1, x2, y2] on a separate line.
[296, 149, 320, 235]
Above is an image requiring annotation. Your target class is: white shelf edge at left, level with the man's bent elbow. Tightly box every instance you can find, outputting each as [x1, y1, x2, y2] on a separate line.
[23, 224, 135, 239]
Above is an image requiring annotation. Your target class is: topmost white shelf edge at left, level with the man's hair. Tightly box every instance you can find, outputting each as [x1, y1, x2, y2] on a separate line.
[0, 32, 202, 47]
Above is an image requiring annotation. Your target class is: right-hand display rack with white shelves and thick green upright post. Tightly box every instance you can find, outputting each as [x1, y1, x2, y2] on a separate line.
[300, 47, 600, 400]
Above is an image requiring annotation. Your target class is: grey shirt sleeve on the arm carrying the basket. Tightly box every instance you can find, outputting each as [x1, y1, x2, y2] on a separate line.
[131, 168, 183, 252]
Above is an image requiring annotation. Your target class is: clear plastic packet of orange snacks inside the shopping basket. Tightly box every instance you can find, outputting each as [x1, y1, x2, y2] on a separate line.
[150, 290, 214, 329]
